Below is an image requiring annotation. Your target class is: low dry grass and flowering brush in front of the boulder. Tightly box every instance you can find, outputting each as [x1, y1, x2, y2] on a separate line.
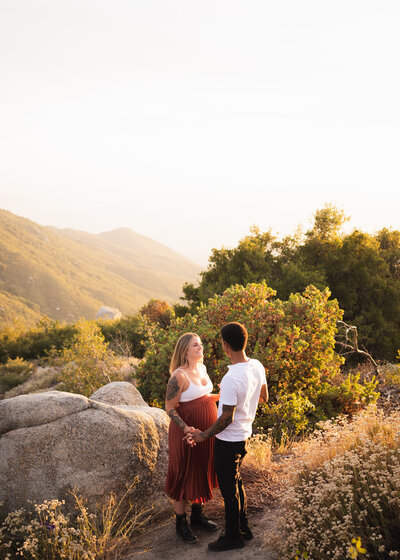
[0, 489, 148, 560]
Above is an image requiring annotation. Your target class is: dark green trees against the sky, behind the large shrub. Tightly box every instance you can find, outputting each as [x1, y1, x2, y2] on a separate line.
[180, 204, 400, 360]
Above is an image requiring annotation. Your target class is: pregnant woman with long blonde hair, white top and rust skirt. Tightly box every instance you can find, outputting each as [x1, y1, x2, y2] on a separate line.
[165, 333, 219, 543]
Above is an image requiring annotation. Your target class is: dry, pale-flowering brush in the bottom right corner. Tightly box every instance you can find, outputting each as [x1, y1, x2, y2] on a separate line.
[278, 408, 400, 560]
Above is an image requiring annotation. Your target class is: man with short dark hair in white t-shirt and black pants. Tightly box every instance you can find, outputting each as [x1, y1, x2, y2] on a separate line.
[189, 322, 268, 551]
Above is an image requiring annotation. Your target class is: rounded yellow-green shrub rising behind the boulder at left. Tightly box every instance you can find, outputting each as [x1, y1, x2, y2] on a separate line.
[52, 319, 123, 396]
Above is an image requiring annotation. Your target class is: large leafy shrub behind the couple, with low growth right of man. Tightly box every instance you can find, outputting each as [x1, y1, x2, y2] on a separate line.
[136, 283, 378, 441]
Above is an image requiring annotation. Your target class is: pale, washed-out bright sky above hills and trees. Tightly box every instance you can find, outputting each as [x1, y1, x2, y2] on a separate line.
[0, 0, 400, 265]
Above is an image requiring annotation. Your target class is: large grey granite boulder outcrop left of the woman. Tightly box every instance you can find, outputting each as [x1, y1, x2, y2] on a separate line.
[0, 382, 169, 513]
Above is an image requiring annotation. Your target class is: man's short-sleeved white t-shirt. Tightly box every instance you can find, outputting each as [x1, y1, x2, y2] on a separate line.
[215, 359, 267, 441]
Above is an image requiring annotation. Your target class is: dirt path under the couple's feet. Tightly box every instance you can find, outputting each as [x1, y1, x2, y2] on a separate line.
[124, 491, 278, 560]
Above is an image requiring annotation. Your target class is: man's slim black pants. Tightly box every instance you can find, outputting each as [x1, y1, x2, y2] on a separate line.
[214, 438, 247, 537]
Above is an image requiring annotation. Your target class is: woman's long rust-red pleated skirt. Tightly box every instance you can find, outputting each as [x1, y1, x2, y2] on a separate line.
[165, 395, 218, 503]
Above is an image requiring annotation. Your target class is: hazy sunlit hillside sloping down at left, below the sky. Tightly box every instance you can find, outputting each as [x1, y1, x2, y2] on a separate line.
[0, 210, 200, 326]
